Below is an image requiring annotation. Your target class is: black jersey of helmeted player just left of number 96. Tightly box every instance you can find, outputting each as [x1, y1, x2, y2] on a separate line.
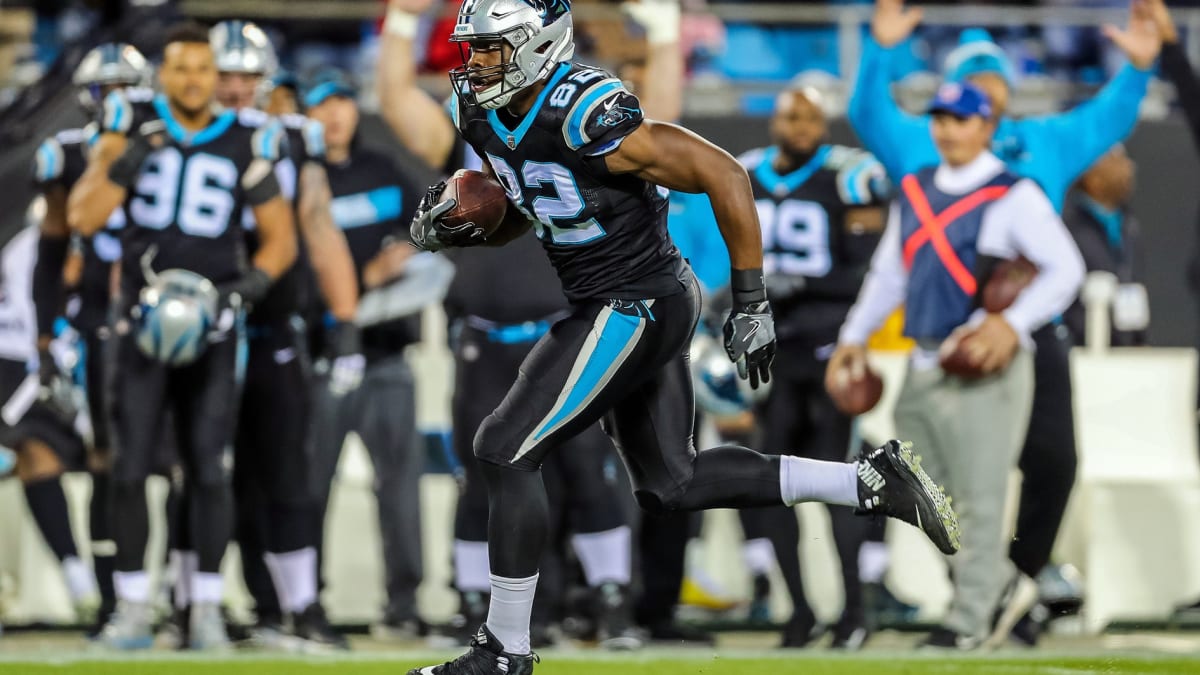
[34, 124, 125, 330]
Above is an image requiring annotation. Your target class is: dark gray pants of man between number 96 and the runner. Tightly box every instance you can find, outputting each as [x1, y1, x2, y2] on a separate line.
[313, 356, 425, 621]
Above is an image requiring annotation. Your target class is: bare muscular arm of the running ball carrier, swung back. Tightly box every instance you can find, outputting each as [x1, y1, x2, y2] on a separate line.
[605, 120, 762, 270]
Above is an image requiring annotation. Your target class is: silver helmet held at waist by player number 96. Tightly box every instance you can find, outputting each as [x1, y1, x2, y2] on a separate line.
[134, 269, 218, 366]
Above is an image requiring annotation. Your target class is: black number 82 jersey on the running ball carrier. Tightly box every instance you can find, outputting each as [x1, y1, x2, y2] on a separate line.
[450, 62, 684, 301]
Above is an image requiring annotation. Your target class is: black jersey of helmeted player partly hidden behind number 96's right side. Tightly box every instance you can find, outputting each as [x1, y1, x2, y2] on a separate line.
[242, 115, 322, 325]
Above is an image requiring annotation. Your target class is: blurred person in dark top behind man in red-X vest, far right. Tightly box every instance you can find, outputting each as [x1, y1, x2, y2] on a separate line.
[1062, 145, 1150, 347]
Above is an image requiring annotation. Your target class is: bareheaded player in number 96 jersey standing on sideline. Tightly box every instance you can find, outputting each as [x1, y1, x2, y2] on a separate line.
[67, 24, 296, 649]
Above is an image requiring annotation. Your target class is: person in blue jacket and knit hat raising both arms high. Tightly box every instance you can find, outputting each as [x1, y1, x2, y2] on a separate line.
[847, 0, 1162, 211]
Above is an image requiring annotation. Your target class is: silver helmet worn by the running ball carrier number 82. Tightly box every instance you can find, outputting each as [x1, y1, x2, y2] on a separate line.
[450, 0, 575, 109]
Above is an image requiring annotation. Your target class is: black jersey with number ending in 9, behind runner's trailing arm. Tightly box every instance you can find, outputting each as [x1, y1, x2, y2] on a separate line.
[740, 145, 887, 345]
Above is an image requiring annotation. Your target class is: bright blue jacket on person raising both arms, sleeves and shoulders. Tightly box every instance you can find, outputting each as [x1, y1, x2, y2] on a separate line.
[847, 37, 1152, 213]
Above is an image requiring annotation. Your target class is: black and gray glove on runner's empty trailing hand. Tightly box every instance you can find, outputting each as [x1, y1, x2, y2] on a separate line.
[725, 269, 775, 389]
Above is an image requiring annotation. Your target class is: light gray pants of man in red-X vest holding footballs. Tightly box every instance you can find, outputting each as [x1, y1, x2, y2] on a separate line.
[895, 350, 1033, 637]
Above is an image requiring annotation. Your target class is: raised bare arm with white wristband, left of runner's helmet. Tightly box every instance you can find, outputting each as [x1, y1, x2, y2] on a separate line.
[376, 0, 457, 169]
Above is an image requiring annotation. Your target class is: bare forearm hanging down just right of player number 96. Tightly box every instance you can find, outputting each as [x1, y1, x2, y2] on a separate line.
[296, 162, 359, 321]
